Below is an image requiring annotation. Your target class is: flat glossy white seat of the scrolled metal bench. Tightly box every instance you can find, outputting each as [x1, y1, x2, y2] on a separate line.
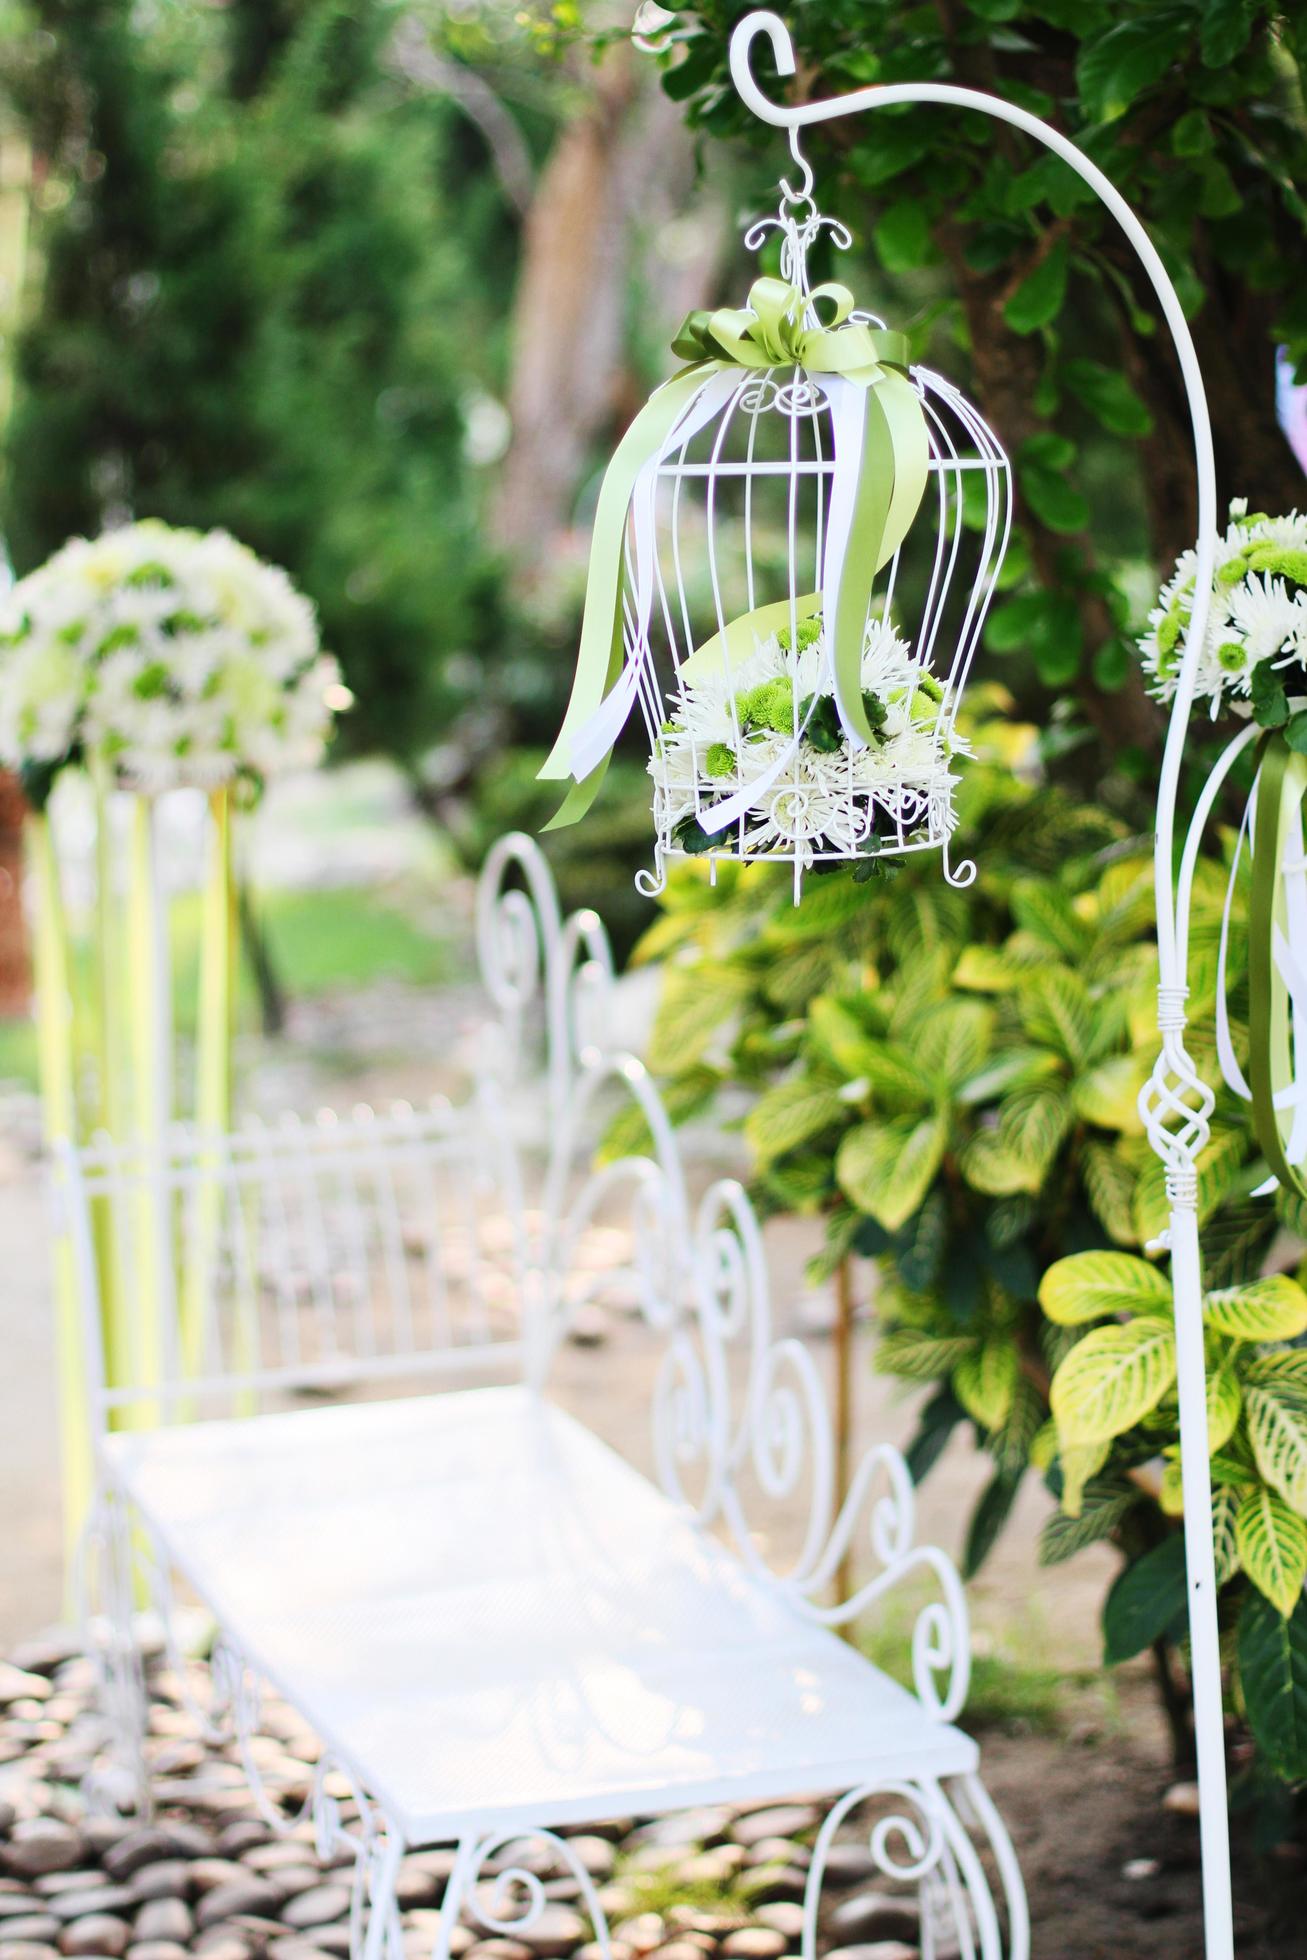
[106, 1388, 978, 1844]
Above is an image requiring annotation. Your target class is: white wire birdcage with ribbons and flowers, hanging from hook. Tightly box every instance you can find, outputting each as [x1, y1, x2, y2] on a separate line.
[547, 186, 1011, 900]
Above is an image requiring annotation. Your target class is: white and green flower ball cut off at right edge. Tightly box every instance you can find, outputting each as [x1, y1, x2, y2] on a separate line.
[1138, 498, 1307, 719]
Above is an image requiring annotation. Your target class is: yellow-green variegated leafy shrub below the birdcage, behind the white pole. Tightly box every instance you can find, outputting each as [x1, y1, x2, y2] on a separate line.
[637, 725, 1307, 1774]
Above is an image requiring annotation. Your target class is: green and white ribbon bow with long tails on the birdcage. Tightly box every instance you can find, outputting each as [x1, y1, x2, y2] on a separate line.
[539, 278, 929, 829]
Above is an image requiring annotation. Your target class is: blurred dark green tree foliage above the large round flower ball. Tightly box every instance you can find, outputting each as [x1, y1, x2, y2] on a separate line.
[0, 0, 513, 759]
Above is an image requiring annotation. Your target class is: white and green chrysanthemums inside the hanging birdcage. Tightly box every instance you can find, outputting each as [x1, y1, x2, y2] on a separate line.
[649, 617, 964, 868]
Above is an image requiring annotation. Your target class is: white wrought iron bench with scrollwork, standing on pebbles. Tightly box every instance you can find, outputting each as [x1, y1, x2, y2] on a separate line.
[59, 839, 1029, 1960]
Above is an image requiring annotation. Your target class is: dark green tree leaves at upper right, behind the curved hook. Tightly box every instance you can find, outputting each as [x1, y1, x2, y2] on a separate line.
[650, 0, 1307, 762]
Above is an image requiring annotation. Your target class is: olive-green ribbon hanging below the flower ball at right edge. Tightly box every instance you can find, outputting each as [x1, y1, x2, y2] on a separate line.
[1248, 729, 1307, 1198]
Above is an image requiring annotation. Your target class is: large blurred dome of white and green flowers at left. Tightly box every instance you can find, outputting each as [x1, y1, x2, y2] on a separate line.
[0, 517, 349, 792]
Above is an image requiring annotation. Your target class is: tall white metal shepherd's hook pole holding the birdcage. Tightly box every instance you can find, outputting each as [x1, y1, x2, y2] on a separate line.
[731, 12, 1234, 1960]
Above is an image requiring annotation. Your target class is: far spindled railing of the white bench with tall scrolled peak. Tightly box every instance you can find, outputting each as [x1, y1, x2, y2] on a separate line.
[55, 835, 611, 1427]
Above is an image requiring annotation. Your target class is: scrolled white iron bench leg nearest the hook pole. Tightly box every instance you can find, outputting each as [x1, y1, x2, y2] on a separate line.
[801, 1778, 1031, 1960]
